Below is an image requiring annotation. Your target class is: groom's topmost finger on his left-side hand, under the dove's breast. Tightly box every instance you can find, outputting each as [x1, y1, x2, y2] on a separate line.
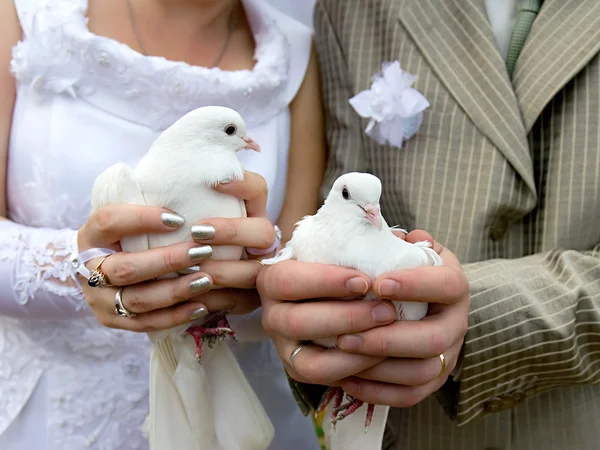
[257, 261, 371, 301]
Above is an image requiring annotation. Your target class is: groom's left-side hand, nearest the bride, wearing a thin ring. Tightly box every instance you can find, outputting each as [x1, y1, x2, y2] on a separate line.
[257, 261, 396, 385]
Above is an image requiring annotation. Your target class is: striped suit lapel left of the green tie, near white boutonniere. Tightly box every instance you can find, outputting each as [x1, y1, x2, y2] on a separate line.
[399, 0, 536, 192]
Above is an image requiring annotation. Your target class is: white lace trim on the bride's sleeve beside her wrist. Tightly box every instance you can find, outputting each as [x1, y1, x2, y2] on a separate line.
[0, 224, 87, 311]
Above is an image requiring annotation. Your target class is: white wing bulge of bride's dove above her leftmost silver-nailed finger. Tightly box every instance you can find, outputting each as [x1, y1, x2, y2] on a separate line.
[92, 163, 149, 252]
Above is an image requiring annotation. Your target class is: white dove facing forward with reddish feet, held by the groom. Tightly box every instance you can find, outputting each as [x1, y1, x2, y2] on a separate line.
[262, 172, 443, 448]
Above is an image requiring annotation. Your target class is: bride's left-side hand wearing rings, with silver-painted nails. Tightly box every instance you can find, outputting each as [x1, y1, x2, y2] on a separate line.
[77, 205, 223, 332]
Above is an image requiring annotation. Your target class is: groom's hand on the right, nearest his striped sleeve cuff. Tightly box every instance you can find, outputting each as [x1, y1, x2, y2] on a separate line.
[338, 231, 470, 407]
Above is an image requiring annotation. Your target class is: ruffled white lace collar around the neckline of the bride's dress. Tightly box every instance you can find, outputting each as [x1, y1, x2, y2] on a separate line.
[11, 0, 290, 130]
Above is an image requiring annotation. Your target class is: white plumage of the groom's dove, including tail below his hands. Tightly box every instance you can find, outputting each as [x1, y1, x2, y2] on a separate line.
[263, 172, 443, 450]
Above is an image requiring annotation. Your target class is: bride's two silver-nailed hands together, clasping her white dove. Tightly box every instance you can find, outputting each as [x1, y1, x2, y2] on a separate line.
[78, 172, 275, 332]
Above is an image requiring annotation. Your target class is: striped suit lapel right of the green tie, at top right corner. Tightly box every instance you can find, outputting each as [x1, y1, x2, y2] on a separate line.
[513, 0, 600, 132]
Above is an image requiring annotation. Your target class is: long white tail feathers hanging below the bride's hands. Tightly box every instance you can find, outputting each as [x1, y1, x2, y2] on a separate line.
[149, 324, 274, 450]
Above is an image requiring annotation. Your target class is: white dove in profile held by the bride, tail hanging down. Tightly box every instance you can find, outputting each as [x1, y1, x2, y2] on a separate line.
[92, 106, 274, 450]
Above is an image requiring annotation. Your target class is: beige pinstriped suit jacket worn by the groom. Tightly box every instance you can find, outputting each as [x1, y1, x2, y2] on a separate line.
[288, 0, 600, 450]
